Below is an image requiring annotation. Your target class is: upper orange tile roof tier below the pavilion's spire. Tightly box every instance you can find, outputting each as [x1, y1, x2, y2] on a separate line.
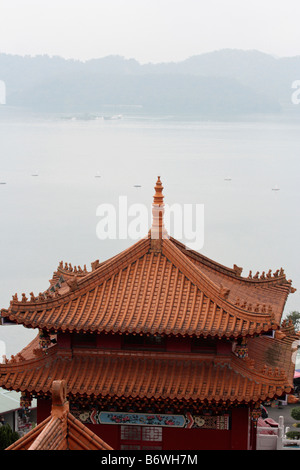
[2, 233, 291, 337]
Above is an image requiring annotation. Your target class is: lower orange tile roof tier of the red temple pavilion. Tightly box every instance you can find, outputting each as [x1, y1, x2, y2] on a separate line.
[0, 337, 292, 402]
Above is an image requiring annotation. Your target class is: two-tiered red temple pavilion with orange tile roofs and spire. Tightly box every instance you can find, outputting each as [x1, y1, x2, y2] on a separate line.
[0, 178, 298, 450]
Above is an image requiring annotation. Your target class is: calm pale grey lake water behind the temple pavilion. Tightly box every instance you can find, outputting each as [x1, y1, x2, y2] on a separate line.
[0, 109, 300, 355]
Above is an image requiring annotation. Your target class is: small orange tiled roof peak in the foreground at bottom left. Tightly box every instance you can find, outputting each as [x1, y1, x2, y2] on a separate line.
[6, 381, 112, 450]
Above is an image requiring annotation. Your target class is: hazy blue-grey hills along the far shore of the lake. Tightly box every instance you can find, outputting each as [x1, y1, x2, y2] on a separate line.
[0, 50, 300, 116]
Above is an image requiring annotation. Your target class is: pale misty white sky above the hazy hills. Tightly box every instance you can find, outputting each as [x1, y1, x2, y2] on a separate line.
[0, 0, 300, 63]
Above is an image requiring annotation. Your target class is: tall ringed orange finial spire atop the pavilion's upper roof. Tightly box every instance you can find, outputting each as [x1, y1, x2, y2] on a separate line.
[151, 176, 168, 250]
